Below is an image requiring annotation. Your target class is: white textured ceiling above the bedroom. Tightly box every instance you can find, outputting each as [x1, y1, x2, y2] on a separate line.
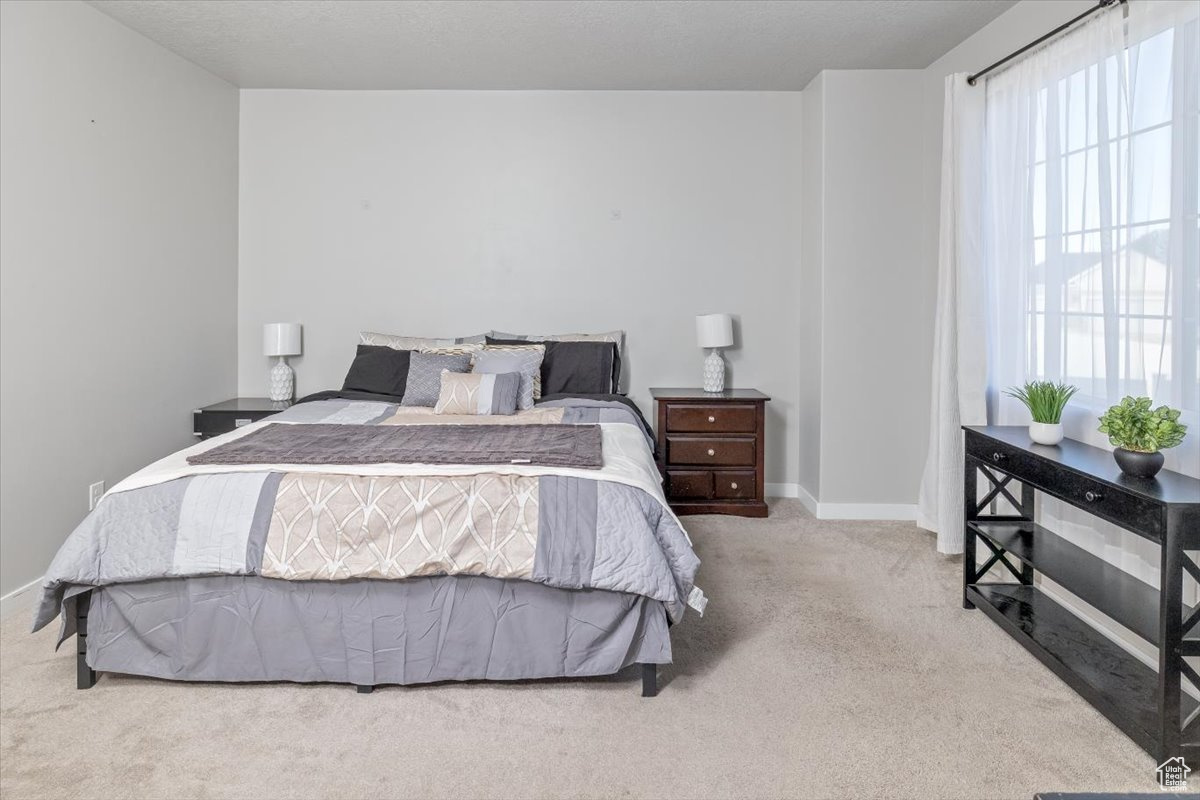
[91, 0, 1013, 90]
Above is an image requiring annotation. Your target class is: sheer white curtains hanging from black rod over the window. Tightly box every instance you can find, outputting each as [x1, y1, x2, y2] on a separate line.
[918, 0, 1200, 563]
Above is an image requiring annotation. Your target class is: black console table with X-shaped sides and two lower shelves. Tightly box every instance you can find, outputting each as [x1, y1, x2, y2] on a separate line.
[962, 426, 1200, 763]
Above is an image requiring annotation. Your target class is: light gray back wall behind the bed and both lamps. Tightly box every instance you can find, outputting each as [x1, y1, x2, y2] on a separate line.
[239, 90, 802, 485]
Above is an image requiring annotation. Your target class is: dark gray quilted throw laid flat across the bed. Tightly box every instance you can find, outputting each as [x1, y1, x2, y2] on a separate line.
[187, 423, 604, 469]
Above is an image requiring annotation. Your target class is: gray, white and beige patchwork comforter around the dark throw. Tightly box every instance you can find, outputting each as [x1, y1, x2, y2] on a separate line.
[34, 399, 700, 642]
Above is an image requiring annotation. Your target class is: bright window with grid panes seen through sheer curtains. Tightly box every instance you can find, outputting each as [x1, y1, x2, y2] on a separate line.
[1021, 22, 1200, 416]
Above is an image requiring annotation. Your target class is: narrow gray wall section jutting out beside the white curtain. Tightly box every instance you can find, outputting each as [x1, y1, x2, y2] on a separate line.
[800, 70, 936, 506]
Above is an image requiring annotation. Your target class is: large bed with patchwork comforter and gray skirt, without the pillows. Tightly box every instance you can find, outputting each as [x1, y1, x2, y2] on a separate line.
[34, 392, 704, 696]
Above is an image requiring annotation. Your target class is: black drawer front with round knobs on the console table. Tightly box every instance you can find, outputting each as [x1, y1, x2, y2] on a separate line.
[967, 435, 1163, 537]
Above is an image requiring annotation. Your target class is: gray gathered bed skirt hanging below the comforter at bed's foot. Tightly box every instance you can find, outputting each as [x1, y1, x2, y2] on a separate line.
[88, 576, 671, 686]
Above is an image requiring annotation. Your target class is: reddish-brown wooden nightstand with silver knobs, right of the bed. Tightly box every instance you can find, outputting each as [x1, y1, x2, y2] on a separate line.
[650, 389, 770, 517]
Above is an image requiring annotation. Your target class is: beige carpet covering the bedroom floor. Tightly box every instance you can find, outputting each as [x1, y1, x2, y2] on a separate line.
[0, 501, 1157, 800]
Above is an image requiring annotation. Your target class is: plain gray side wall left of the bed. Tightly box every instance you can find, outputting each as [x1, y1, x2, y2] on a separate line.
[0, 1, 238, 595]
